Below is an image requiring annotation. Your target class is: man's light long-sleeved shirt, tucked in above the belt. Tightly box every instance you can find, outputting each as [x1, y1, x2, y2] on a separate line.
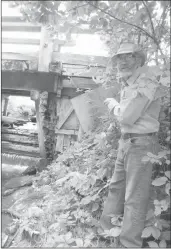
[114, 65, 164, 134]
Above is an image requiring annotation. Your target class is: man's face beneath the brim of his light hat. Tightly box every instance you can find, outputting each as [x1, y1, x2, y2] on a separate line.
[116, 53, 138, 74]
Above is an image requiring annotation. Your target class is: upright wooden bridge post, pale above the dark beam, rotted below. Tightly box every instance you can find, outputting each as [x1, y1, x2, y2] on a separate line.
[35, 26, 58, 162]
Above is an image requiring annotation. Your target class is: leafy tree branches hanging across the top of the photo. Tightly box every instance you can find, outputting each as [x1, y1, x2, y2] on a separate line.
[10, 1, 170, 62]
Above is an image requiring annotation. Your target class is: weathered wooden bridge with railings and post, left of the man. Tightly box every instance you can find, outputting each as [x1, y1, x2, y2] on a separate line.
[2, 17, 108, 165]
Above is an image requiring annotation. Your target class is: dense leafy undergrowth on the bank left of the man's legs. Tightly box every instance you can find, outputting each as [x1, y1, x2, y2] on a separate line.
[12, 115, 121, 247]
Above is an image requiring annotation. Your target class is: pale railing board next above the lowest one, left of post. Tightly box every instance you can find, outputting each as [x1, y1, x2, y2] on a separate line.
[2, 37, 40, 45]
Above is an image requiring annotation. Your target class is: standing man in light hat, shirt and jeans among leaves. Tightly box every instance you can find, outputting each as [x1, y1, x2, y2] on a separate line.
[100, 43, 160, 248]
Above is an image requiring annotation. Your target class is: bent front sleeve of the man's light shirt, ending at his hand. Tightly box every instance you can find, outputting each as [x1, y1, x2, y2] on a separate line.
[114, 92, 150, 125]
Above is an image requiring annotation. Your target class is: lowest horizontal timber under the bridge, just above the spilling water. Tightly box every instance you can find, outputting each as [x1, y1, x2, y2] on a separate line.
[1, 141, 40, 155]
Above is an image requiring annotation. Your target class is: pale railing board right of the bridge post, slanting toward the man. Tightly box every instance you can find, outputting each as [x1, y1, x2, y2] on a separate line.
[52, 52, 109, 67]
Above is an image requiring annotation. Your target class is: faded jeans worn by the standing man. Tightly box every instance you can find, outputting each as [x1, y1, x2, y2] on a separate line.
[100, 136, 159, 248]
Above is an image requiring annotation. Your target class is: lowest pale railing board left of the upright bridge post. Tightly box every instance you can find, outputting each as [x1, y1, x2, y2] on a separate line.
[1, 52, 38, 61]
